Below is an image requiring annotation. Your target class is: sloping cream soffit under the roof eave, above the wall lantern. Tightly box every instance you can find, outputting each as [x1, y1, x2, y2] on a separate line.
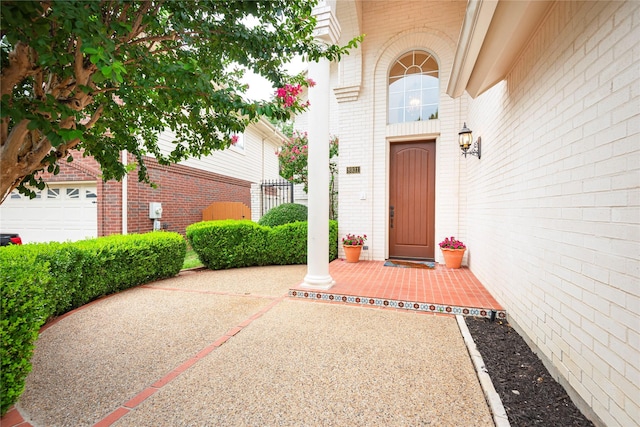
[447, 0, 553, 98]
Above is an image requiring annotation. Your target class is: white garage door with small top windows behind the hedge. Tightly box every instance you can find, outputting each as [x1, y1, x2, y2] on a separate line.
[0, 183, 98, 243]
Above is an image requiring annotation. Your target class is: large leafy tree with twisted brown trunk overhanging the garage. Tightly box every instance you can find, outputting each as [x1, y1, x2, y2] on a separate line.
[0, 0, 360, 202]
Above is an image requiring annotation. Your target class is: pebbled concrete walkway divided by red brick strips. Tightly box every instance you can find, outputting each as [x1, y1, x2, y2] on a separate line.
[2, 266, 494, 426]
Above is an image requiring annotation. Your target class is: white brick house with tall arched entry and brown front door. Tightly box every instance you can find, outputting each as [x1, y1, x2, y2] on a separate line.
[296, 0, 640, 426]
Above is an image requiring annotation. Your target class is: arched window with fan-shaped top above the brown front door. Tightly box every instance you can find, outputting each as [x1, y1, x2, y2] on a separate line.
[388, 50, 440, 124]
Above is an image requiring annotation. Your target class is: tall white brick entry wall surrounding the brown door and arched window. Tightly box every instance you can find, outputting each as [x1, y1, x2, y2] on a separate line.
[332, 2, 466, 260]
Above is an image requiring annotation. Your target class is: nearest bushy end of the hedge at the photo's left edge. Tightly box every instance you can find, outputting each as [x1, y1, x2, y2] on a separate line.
[0, 245, 52, 415]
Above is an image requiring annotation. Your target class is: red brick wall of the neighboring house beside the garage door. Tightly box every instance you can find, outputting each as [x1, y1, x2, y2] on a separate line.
[34, 152, 251, 236]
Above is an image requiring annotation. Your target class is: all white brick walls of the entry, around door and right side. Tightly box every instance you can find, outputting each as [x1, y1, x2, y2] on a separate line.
[297, 1, 640, 426]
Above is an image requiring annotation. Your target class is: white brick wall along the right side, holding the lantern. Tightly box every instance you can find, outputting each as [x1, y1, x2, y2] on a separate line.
[461, 1, 640, 426]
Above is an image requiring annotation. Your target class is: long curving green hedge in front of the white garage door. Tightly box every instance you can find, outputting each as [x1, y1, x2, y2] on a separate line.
[0, 232, 186, 415]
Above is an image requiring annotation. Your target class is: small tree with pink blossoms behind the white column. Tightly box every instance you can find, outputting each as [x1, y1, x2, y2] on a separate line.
[276, 130, 339, 219]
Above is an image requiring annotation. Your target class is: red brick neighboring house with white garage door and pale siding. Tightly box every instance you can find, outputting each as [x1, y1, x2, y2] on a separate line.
[0, 120, 285, 243]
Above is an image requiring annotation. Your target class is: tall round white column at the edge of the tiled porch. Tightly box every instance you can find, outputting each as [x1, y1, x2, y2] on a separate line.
[302, 4, 339, 290]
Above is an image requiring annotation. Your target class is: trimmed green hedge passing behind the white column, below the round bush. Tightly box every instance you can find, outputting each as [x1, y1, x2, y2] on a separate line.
[187, 220, 338, 270]
